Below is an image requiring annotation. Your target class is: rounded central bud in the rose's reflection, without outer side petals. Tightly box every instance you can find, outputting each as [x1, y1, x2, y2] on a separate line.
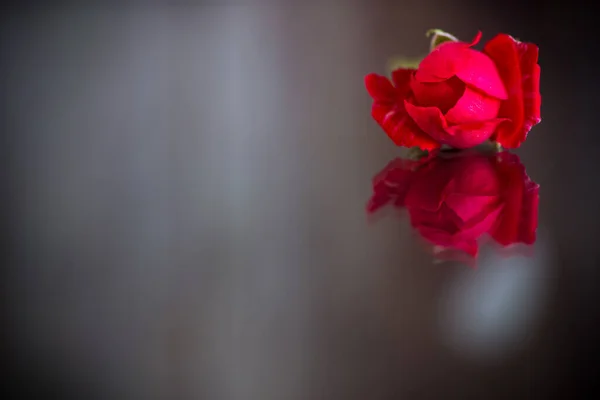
[405, 153, 503, 255]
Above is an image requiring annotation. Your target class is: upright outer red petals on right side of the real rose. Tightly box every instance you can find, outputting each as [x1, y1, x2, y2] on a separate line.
[484, 34, 541, 148]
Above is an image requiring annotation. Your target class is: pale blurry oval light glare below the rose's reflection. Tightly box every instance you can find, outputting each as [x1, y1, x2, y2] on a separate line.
[439, 234, 549, 362]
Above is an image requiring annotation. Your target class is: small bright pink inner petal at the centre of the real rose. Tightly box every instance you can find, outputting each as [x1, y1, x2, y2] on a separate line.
[441, 86, 500, 124]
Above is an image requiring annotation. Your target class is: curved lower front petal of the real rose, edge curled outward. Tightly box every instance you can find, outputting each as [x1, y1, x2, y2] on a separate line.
[404, 101, 503, 149]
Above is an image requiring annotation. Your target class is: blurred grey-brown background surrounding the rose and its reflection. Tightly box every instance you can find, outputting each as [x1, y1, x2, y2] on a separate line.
[0, 0, 600, 400]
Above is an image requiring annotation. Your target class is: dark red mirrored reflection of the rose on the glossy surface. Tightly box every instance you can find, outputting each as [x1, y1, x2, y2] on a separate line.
[367, 152, 539, 256]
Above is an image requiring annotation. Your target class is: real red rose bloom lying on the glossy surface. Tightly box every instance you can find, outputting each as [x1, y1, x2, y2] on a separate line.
[365, 32, 541, 150]
